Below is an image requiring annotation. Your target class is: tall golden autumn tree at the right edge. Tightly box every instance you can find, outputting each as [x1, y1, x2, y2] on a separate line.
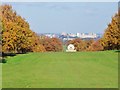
[101, 14, 120, 50]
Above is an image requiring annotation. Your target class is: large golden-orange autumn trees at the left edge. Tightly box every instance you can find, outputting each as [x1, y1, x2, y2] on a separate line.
[0, 5, 45, 53]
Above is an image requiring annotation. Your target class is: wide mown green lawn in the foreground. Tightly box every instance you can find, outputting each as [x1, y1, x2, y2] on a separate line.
[2, 51, 118, 88]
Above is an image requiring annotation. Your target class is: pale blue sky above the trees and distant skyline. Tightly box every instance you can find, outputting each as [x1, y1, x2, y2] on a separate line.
[2, 2, 118, 33]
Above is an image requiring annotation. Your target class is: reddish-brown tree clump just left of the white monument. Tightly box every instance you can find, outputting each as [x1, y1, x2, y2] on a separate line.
[41, 38, 63, 52]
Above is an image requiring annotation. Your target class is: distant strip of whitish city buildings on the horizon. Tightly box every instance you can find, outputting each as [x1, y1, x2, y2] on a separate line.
[39, 32, 102, 41]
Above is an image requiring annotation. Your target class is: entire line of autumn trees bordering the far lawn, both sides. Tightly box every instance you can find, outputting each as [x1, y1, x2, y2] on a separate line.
[0, 5, 120, 56]
